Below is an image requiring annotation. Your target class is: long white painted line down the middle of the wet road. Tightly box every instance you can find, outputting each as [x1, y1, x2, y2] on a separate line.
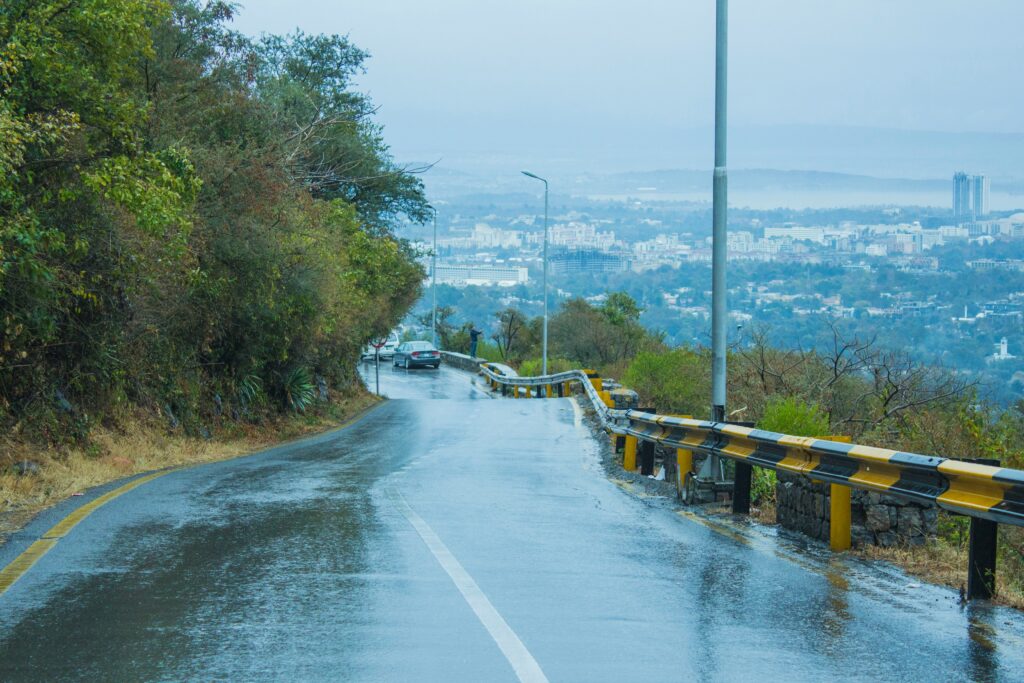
[387, 488, 548, 683]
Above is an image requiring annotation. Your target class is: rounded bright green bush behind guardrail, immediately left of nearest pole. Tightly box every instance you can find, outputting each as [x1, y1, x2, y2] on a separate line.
[623, 347, 711, 418]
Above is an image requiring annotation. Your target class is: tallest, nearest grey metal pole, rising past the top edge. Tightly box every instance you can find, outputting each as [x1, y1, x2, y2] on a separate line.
[711, 0, 729, 422]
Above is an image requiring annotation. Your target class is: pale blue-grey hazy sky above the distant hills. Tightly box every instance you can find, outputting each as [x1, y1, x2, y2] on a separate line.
[236, 0, 1024, 174]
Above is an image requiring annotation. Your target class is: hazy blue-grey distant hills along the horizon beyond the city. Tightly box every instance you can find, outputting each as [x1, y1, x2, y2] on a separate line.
[396, 122, 1024, 208]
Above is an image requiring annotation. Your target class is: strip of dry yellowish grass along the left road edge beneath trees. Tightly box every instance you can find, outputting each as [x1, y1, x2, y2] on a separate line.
[0, 392, 379, 543]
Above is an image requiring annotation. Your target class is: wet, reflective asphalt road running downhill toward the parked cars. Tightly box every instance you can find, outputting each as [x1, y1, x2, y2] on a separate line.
[0, 360, 1024, 681]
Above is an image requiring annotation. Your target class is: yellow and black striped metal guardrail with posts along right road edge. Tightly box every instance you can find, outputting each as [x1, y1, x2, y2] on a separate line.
[480, 365, 1024, 598]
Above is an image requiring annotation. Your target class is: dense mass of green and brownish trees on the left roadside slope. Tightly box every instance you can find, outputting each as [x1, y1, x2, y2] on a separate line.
[0, 0, 427, 440]
